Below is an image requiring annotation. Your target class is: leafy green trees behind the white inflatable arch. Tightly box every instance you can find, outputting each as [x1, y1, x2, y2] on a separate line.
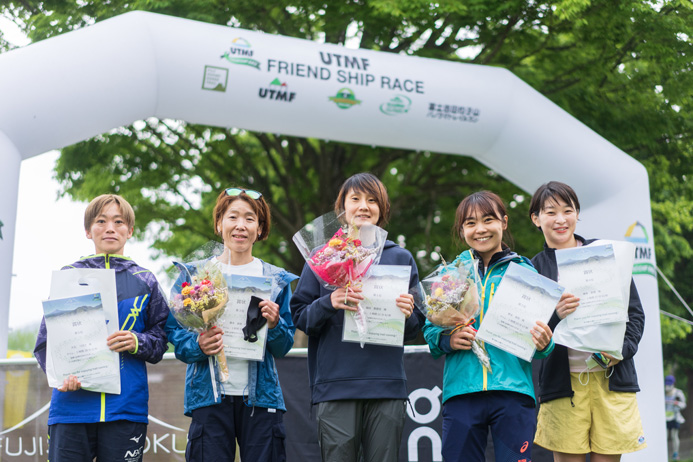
[0, 0, 693, 350]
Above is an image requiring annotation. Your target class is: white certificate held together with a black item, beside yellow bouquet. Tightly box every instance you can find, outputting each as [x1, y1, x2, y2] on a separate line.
[220, 274, 272, 361]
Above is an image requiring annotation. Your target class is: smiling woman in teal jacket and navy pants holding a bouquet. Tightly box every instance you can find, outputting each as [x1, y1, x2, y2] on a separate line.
[423, 191, 553, 462]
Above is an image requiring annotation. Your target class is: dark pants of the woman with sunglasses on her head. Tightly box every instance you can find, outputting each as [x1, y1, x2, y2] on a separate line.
[185, 396, 286, 462]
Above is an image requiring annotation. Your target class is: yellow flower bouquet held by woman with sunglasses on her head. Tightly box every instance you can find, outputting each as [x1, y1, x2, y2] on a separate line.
[169, 258, 229, 382]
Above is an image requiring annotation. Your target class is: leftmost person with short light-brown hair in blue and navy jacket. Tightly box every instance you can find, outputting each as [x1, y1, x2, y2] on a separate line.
[34, 194, 169, 462]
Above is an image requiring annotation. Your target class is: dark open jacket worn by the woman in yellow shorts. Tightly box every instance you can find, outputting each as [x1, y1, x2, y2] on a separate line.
[532, 234, 645, 403]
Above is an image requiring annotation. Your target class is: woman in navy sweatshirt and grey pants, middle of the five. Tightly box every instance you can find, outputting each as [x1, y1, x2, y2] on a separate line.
[291, 173, 424, 462]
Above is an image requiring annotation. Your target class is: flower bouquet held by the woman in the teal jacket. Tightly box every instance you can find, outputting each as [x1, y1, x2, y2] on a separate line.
[421, 261, 492, 372]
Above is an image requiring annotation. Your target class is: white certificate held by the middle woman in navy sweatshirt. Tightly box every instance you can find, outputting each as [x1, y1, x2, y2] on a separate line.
[342, 265, 411, 347]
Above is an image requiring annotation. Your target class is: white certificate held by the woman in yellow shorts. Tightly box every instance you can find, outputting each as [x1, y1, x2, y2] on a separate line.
[556, 244, 628, 329]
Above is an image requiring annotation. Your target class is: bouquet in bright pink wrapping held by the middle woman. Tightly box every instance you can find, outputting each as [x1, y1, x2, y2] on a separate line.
[293, 212, 387, 346]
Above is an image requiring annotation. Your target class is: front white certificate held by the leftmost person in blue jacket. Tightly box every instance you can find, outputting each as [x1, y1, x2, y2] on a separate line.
[43, 294, 120, 393]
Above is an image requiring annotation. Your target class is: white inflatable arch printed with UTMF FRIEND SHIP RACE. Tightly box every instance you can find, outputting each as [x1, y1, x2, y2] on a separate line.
[0, 12, 666, 461]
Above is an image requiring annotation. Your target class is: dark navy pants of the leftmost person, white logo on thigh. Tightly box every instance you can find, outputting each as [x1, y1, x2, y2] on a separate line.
[48, 420, 147, 462]
